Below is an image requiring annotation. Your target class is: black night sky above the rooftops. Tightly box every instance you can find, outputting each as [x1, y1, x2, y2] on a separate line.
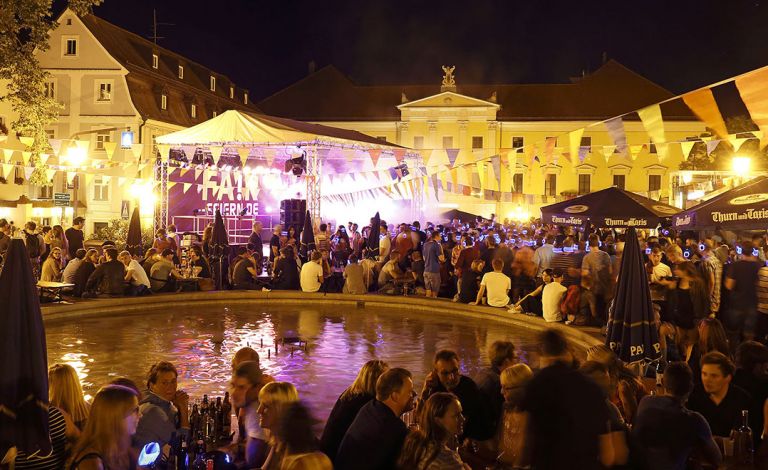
[87, 0, 768, 98]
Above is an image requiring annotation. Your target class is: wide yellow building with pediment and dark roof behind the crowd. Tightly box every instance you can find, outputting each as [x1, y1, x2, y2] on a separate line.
[258, 60, 705, 218]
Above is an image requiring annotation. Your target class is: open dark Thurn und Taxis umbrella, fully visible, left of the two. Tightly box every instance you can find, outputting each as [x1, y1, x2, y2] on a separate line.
[541, 187, 680, 228]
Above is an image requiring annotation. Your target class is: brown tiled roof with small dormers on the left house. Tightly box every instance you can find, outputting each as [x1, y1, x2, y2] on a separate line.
[81, 14, 258, 127]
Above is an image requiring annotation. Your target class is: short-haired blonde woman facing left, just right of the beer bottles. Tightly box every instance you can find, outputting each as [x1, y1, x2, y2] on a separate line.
[257, 382, 299, 470]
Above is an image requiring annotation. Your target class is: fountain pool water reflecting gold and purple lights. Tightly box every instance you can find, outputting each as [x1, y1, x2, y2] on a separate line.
[46, 306, 534, 419]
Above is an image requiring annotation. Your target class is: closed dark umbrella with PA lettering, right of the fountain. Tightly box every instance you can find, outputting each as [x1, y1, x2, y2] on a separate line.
[606, 228, 661, 365]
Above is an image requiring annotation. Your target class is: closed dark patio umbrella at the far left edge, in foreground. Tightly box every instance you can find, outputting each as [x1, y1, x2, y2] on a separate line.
[0, 239, 51, 459]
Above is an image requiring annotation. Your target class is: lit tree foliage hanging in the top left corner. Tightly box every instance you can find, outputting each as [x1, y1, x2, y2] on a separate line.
[0, 0, 103, 186]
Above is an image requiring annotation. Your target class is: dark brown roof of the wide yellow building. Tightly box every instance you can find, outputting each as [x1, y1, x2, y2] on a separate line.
[258, 60, 694, 121]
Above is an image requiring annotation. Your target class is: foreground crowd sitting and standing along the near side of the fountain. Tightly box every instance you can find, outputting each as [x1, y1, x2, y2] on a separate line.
[10, 329, 768, 470]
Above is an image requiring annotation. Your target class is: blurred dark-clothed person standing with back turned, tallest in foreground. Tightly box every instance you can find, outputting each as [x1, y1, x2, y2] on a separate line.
[516, 329, 615, 470]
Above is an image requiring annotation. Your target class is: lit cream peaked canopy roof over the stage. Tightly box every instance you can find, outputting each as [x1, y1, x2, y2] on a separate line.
[157, 110, 403, 150]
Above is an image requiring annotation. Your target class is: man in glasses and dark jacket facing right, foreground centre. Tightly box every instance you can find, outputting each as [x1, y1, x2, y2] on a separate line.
[333, 367, 415, 470]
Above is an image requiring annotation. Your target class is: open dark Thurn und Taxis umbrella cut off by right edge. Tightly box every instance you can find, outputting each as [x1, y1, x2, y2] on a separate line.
[672, 176, 768, 230]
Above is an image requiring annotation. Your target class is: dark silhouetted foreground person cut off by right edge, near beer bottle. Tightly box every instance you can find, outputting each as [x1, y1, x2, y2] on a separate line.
[732, 341, 768, 449]
